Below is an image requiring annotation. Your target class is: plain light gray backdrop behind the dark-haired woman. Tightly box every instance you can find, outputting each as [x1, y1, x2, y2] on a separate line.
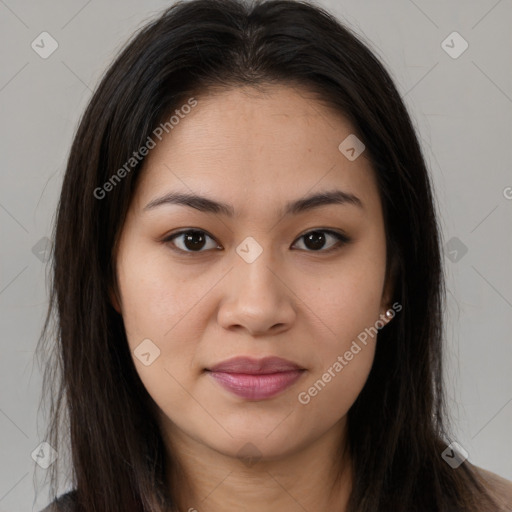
[0, 0, 512, 512]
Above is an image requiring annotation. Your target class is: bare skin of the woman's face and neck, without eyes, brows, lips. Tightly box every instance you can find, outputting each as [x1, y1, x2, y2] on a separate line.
[112, 85, 391, 512]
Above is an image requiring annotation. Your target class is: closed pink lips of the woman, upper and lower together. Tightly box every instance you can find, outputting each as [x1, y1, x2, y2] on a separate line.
[207, 357, 304, 400]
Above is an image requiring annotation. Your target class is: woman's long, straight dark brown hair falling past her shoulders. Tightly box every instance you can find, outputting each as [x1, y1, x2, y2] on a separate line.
[37, 0, 500, 512]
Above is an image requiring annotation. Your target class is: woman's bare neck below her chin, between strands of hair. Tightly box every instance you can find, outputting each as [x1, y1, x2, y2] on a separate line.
[162, 424, 352, 512]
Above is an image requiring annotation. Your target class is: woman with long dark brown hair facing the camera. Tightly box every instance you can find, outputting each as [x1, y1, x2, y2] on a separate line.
[39, 0, 512, 512]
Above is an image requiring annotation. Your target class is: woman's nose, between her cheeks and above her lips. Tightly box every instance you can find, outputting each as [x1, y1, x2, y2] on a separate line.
[218, 250, 296, 336]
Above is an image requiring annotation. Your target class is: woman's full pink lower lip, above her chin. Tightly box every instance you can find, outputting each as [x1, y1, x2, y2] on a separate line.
[208, 370, 304, 400]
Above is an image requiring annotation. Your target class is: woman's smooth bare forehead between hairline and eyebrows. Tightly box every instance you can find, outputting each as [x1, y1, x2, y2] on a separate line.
[132, 85, 379, 218]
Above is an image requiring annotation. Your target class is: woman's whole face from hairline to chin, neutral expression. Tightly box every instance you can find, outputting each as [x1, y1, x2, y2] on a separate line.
[112, 86, 389, 464]
